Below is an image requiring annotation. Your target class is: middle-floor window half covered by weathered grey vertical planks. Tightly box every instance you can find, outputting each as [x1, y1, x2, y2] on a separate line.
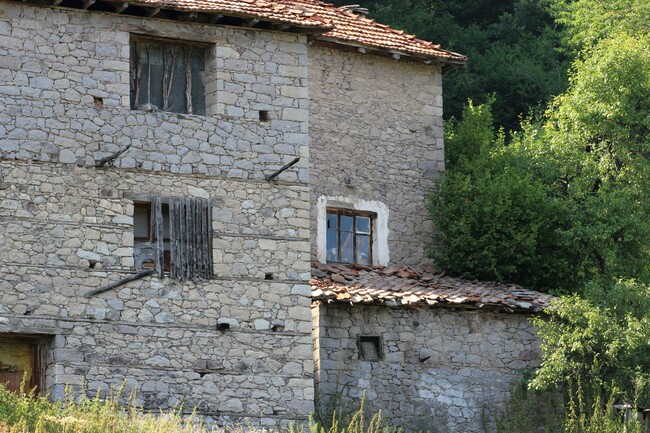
[133, 197, 212, 280]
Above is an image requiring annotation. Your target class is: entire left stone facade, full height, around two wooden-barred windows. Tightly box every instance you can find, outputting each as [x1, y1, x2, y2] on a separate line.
[0, 1, 313, 425]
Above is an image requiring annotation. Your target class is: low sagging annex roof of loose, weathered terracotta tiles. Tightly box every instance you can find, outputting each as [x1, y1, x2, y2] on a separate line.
[310, 262, 553, 313]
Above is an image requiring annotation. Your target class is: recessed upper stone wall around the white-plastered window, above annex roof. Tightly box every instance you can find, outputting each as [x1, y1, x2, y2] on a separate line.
[308, 45, 444, 265]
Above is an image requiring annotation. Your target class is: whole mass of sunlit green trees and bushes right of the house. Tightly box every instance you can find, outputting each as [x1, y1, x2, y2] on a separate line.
[431, 0, 650, 433]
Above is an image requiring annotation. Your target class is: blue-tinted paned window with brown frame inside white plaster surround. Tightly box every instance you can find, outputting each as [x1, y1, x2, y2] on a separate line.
[327, 209, 372, 265]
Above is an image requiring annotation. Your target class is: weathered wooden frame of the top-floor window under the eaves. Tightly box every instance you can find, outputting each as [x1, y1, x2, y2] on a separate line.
[129, 33, 213, 116]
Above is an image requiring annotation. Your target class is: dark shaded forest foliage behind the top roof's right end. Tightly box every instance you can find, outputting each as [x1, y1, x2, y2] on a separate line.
[335, 0, 569, 130]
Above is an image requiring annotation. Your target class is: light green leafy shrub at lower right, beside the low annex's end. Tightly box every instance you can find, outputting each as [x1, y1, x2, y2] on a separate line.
[531, 280, 650, 407]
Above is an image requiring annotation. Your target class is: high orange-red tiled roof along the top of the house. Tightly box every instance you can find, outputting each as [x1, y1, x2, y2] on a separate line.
[120, 0, 466, 65]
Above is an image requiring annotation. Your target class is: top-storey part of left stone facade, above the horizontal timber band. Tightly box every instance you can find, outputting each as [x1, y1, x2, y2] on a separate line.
[0, 2, 308, 182]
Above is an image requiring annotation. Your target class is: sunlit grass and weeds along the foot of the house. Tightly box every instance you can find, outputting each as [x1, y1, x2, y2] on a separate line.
[0, 385, 400, 433]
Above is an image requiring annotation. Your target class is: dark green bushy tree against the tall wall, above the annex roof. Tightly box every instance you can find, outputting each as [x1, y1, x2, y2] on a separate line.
[430, 103, 578, 290]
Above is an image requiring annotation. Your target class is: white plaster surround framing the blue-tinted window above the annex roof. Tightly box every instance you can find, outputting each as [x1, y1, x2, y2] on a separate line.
[316, 195, 390, 266]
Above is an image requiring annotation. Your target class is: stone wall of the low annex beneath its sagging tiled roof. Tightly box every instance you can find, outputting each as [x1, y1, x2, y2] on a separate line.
[312, 304, 539, 433]
